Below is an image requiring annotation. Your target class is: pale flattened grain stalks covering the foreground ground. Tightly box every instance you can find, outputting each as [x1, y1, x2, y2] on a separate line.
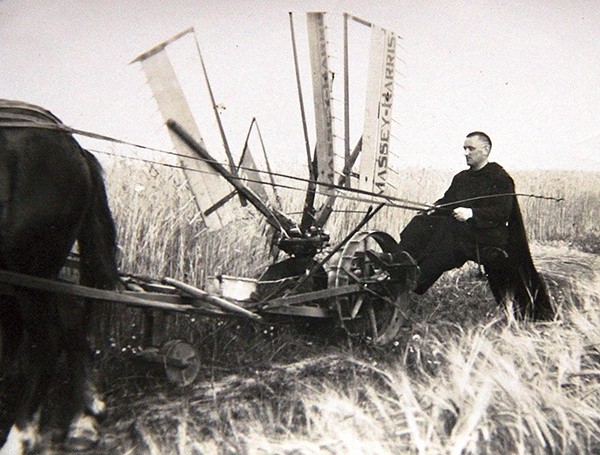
[98, 253, 600, 454]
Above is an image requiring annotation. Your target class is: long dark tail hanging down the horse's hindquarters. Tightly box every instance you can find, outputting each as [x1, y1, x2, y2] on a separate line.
[77, 150, 119, 289]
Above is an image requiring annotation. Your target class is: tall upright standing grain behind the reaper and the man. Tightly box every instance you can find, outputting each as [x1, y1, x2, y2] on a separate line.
[107, 161, 600, 276]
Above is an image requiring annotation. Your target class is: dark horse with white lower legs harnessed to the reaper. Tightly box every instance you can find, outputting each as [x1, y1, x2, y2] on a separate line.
[0, 100, 118, 453]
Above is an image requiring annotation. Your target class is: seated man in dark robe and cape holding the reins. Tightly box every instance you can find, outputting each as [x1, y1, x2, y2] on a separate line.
[399, 131, 554, 320]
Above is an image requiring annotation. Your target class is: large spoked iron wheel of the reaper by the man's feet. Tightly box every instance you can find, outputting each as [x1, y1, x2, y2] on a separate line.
[329, 231, 417, 346]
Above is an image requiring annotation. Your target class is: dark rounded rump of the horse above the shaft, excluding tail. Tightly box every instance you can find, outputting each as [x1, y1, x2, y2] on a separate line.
[0, 103, 93, 275]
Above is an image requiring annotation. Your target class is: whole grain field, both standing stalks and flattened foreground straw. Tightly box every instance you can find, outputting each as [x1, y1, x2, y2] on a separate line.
[84, 158, 600, 454]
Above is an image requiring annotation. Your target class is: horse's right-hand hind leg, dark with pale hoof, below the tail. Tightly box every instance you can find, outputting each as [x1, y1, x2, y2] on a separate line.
[59, 299, 106, 451]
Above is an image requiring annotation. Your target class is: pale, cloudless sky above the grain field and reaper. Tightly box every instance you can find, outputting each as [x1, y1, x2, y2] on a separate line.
[0, 0, 600, 172]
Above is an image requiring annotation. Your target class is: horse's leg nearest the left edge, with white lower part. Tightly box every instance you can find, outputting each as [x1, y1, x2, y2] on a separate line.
[3, 291, 59, 453]
